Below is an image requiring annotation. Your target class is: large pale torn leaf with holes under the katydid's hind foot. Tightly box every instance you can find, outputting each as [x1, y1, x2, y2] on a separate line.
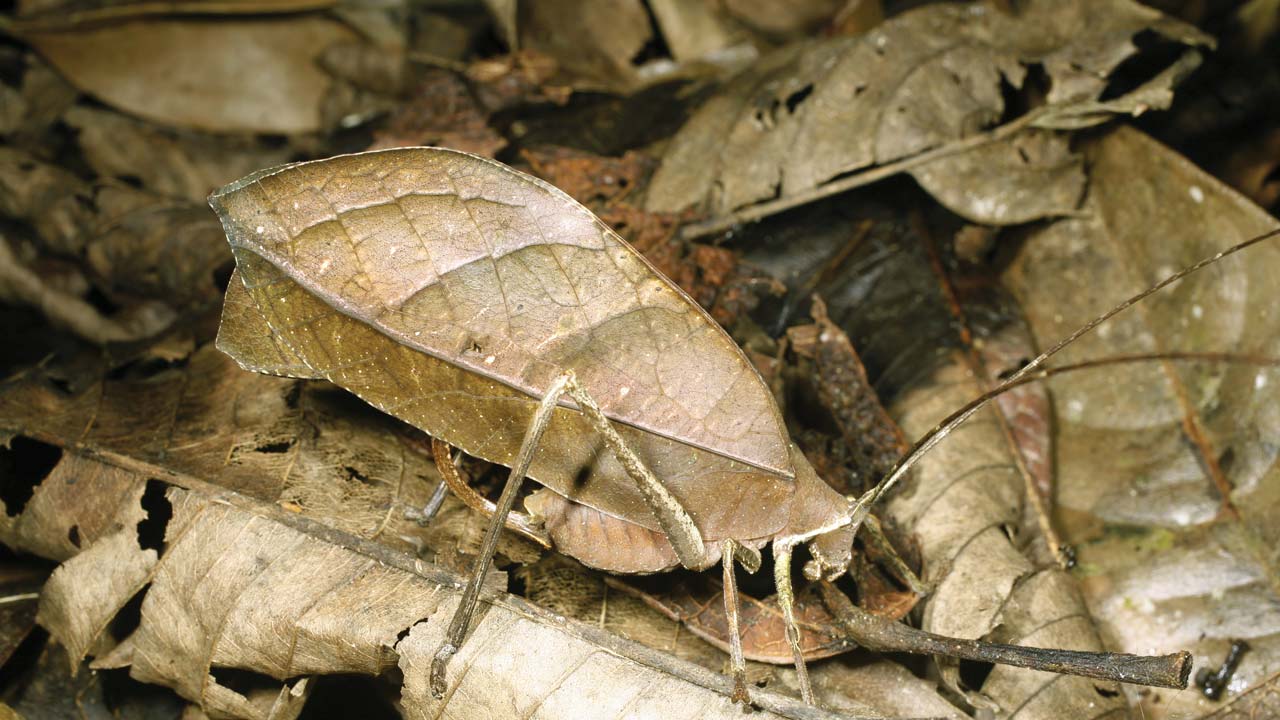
[0, 347, 860, 720]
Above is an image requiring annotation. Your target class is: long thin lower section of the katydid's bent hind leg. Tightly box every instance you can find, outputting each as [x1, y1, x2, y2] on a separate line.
[431, 373, 573, 698]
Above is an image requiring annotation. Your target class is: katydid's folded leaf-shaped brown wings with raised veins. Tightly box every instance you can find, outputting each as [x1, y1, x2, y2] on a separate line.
[212, 149, 794, 556]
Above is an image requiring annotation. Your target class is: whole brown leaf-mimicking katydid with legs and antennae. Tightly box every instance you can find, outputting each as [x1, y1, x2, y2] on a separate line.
[210, 147, 1262, 702]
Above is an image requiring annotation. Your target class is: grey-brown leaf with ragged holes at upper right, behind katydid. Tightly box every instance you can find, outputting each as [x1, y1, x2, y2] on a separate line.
[648, 0, 1208, 224]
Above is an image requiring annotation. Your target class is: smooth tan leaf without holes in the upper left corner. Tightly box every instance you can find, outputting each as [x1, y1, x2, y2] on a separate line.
[22, 14, 358, 135]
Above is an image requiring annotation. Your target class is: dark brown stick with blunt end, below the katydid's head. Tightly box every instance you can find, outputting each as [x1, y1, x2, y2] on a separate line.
[820, 580, 1192, 689]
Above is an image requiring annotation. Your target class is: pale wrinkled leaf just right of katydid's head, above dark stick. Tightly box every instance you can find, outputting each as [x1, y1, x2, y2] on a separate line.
[886, 354, 1124, 719]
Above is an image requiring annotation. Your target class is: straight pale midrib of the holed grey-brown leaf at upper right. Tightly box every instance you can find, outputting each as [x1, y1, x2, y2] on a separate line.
[680, 105, 1053, 240]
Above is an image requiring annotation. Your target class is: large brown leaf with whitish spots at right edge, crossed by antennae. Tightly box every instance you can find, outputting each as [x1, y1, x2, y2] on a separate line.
[1007, 128, 1280, 717]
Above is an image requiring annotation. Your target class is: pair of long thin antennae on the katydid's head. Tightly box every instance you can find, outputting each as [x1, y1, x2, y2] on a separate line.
[850, 228, 1280, 530]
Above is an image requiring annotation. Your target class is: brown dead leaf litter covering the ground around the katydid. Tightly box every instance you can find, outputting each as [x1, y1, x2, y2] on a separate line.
[0, 1, 1277, 717]
